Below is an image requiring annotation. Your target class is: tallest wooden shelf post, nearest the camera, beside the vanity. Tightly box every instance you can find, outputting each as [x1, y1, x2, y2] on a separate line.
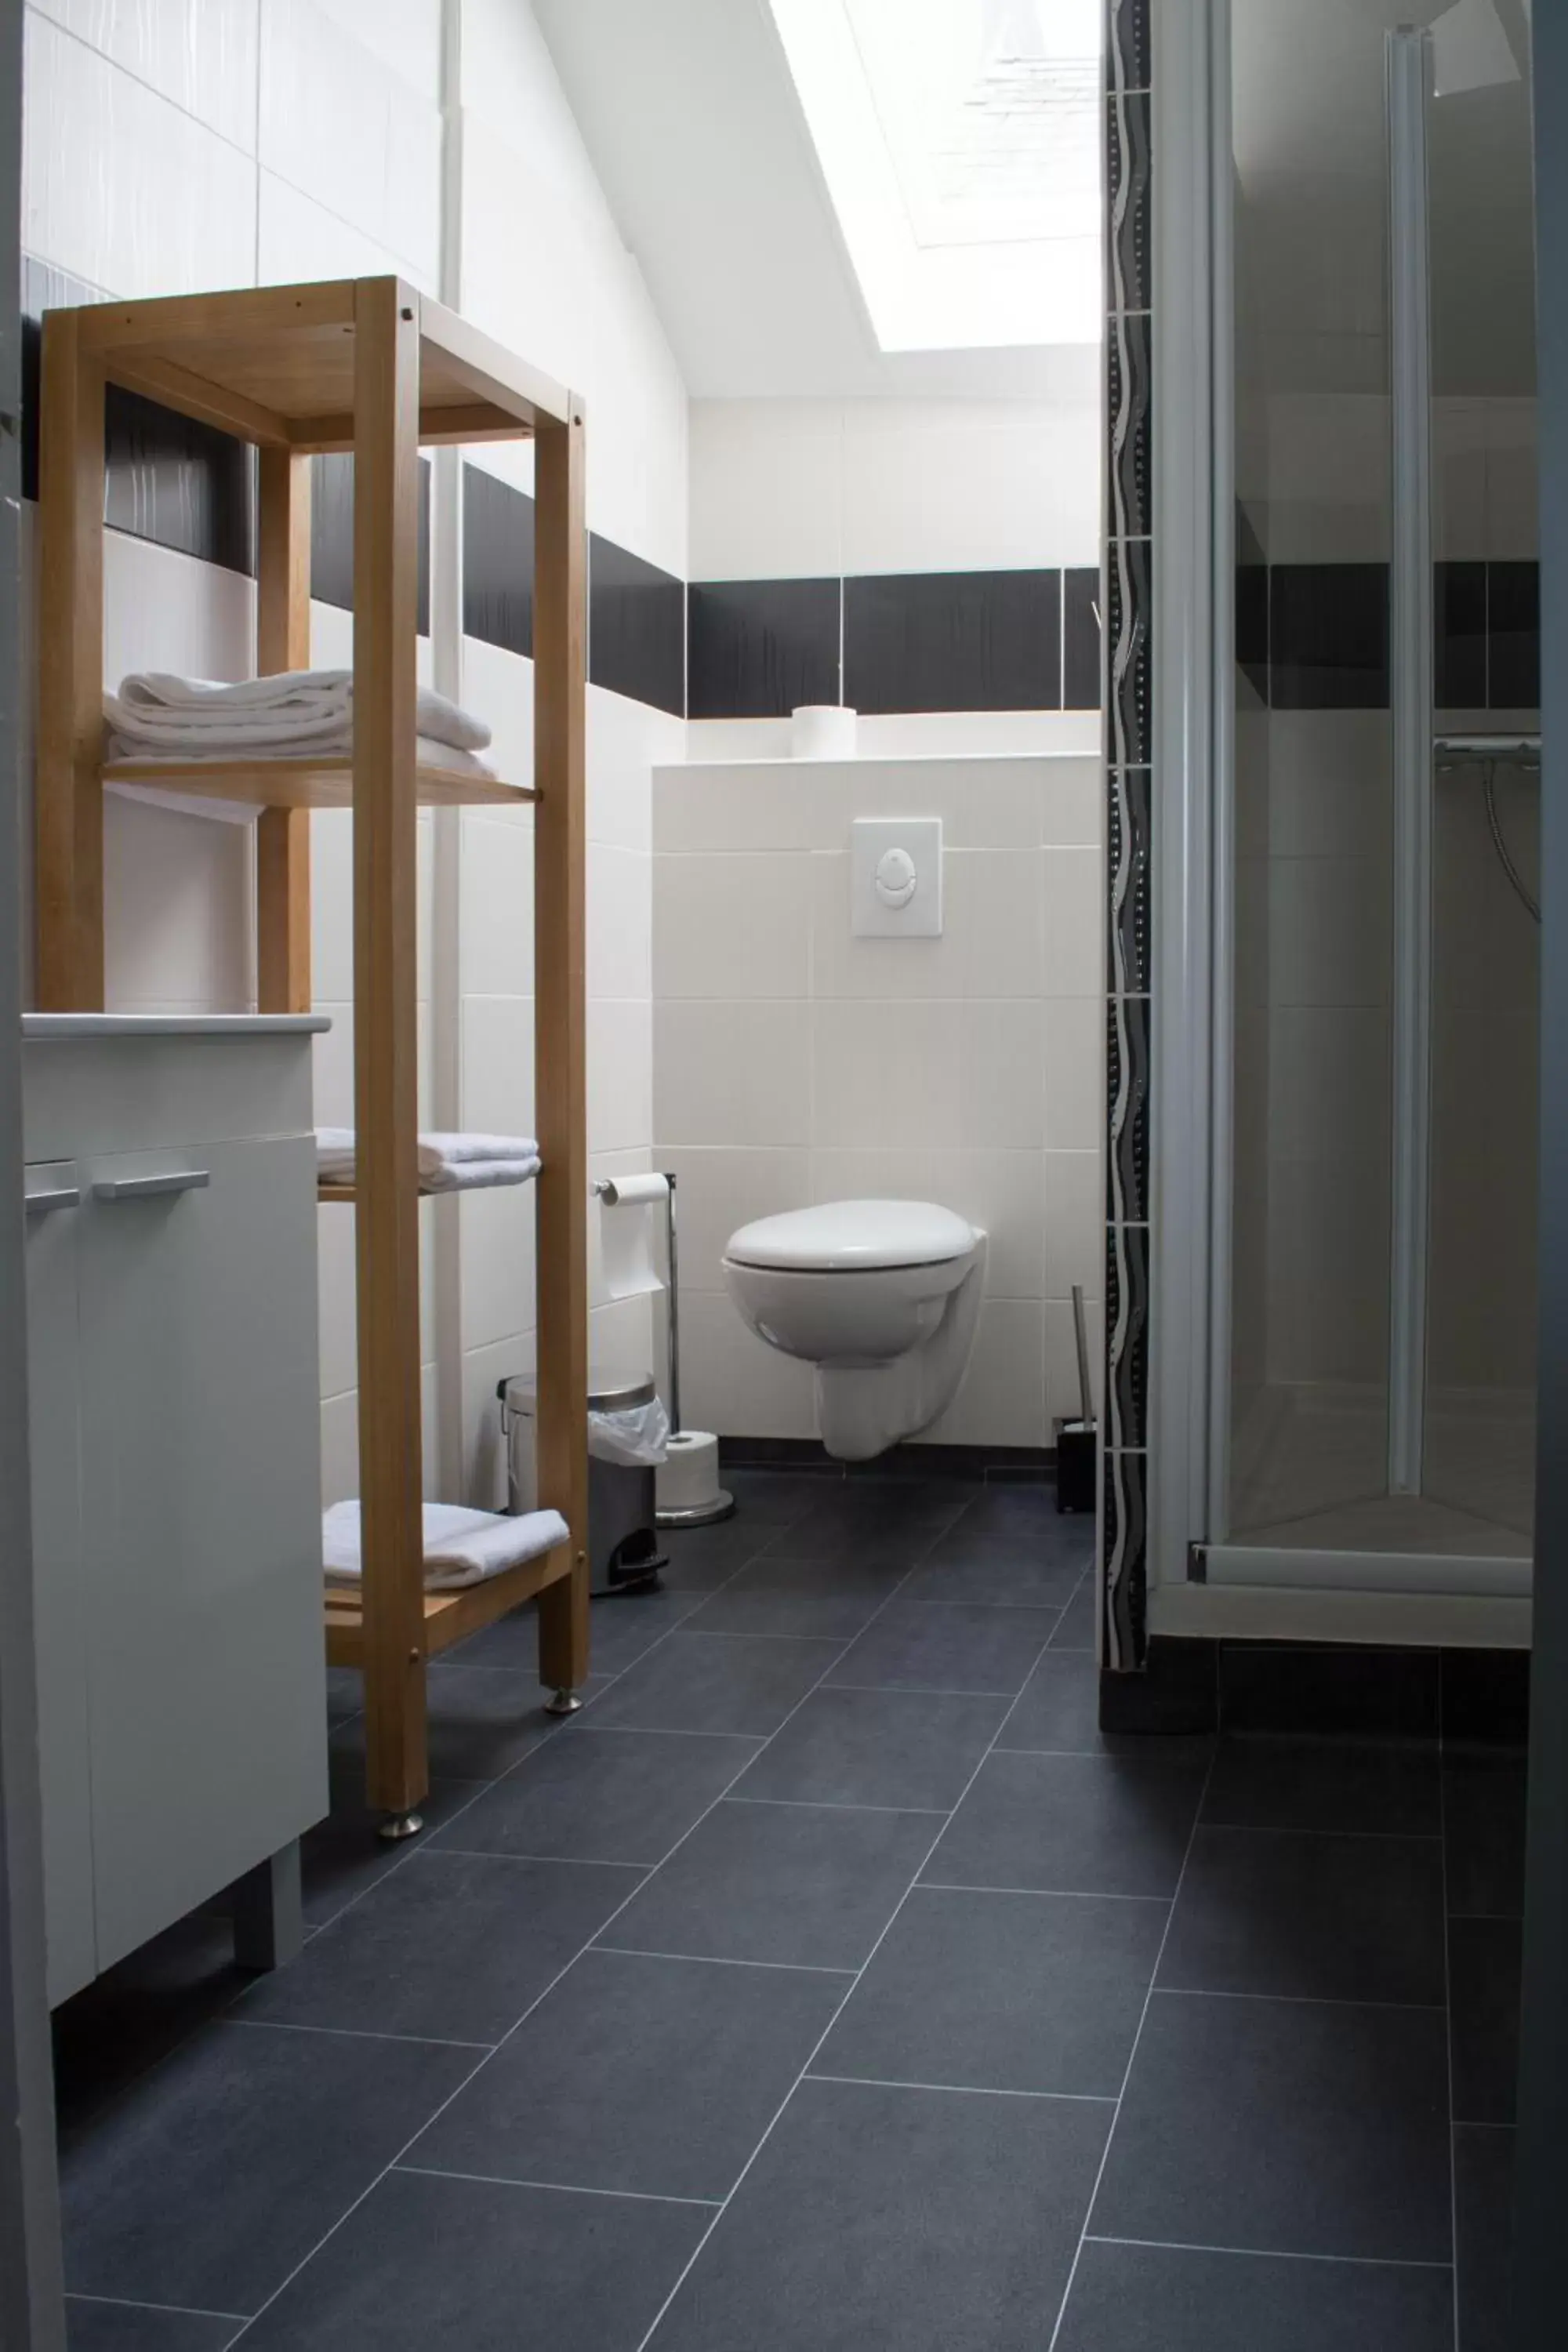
[355, 278, 428, 1828]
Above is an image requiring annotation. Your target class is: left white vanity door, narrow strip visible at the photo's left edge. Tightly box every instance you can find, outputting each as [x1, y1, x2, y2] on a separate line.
[26, 1162, 96, 2002]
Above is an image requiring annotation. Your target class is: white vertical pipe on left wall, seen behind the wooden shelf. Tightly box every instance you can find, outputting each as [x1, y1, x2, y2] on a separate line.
[430, 0, 465, 1503]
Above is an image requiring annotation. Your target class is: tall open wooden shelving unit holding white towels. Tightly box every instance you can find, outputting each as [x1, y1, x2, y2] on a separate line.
[38, 278, 588, 1832]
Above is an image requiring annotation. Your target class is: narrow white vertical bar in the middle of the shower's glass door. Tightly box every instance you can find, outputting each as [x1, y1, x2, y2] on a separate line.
[1387, 28, 1434, 1494]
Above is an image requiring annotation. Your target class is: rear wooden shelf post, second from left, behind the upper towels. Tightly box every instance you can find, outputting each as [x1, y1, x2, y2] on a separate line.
[256, 449, 310, 1014]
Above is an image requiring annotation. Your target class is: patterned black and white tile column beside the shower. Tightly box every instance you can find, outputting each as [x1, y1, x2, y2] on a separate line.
[1100, 0, 1154, 1670]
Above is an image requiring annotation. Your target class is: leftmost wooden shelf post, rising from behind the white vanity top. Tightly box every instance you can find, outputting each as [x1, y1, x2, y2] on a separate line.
[33, 310, 103, 1014]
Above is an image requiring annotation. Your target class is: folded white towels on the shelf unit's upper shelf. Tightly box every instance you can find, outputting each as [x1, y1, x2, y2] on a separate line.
[103, 670, 496, 776]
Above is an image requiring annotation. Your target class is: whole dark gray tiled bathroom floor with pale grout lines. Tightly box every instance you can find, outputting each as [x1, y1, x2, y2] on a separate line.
[49, 1472, 1523, 2352]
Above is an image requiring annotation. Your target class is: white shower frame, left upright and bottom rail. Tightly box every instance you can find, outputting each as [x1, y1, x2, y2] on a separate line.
[1147, 0, 1530, 1646]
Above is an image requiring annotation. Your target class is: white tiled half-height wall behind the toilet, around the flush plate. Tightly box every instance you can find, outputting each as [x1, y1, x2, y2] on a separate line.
[654, 757, 1105, 1446]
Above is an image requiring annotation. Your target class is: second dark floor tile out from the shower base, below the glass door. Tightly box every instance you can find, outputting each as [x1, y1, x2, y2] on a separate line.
[1159, 1823, 1446, 2009]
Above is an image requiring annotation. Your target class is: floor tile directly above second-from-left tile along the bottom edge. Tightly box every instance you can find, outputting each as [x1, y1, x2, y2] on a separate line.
[409, 1952, 848, 2197]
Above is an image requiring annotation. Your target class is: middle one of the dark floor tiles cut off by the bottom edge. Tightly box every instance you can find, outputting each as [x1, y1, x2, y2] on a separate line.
[652, 2082, 1109, 2352]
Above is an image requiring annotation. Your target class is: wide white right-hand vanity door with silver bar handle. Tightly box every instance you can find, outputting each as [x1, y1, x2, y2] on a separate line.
[80, 1136, 327, 1966]
